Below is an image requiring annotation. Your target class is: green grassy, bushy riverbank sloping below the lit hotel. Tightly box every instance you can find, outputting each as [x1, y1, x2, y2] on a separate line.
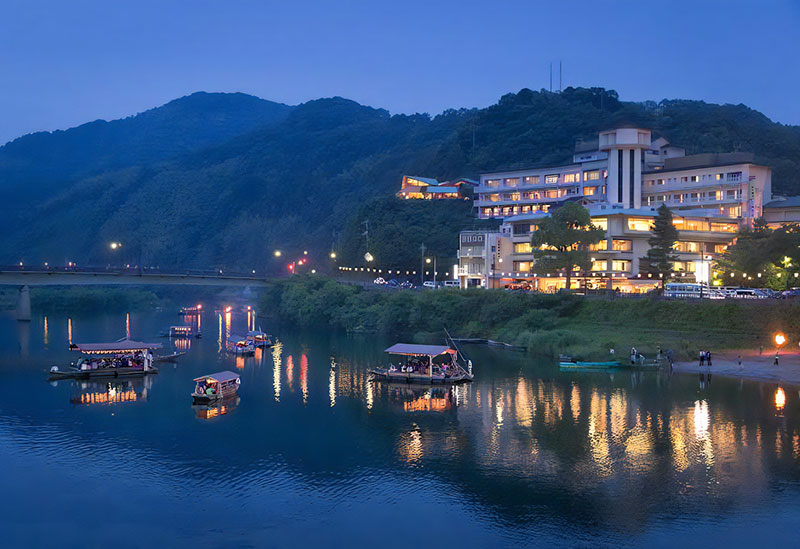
[261, 277, 800, 358]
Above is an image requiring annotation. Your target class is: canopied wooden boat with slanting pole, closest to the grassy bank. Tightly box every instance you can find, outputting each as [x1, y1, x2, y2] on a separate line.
[368, 343, 473, 384]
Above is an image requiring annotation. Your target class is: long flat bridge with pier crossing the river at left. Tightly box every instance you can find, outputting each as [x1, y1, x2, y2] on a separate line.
[0, 267, 268, 321]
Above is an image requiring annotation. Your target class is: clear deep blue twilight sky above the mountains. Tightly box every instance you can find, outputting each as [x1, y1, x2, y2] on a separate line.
[0, 0, 800, 144]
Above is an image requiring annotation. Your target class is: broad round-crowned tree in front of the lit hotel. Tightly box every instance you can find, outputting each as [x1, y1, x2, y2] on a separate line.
[531, 202, 605, 289]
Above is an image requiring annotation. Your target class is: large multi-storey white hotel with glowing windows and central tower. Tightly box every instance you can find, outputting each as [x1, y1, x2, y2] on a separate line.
[458, 128, 772, 291]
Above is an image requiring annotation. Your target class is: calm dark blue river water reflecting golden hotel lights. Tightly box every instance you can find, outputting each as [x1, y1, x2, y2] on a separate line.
[0, 311, 800, 547]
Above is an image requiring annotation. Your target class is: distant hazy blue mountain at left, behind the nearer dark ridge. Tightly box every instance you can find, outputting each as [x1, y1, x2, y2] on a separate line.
[0, 92, 291, 190]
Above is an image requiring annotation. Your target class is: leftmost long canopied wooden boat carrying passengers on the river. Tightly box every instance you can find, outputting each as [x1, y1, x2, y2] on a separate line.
[49, 339, 161, 380]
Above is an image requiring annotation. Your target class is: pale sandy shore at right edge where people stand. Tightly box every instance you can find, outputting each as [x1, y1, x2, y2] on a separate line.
[674, 348, 800, 385]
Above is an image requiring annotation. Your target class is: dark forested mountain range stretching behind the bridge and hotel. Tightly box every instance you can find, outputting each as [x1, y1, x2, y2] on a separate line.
[0, 88, 800, 270]
